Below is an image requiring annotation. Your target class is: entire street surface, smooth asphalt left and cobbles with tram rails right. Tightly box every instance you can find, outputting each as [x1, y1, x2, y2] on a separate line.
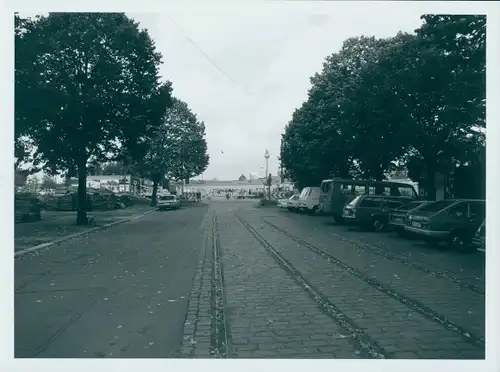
[15, 200, 485, 359]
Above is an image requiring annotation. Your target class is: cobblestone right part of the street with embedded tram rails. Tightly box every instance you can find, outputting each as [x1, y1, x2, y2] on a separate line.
[179, 202, 485, 359]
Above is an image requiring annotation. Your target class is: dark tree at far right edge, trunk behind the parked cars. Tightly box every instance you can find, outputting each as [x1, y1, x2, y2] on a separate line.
[377, 15, 485, 200]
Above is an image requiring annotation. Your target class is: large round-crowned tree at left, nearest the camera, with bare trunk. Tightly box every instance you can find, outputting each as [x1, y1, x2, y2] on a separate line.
[15, 13, 171, 224]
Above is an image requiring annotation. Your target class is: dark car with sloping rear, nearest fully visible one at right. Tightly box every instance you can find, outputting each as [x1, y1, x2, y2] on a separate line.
[405, 199, 486, 250]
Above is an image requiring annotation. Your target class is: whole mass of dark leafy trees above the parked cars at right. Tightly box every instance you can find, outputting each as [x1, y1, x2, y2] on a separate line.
[280, 15, 486, 200]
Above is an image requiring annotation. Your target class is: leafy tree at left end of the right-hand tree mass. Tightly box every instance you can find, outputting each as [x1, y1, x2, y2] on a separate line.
[281, 37, 387, 188]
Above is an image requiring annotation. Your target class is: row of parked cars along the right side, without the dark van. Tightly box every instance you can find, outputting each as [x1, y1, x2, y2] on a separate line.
[278, 189, 486, 252]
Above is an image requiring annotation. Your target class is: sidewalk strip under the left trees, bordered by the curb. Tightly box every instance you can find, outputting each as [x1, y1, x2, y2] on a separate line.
[14, 205, 151, 251]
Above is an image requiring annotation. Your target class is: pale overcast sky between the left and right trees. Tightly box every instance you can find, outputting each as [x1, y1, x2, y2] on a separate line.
[128, 2, 428, 179]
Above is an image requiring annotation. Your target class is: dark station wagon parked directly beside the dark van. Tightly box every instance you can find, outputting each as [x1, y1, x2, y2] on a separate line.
[342, 195, 413, 231]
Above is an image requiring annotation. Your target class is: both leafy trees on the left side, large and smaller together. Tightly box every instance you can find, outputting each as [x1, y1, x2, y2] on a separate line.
[14, 13, 209, 225]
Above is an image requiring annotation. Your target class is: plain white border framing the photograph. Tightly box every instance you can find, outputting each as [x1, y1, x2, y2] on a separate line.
[0, 0, 500, 372]
